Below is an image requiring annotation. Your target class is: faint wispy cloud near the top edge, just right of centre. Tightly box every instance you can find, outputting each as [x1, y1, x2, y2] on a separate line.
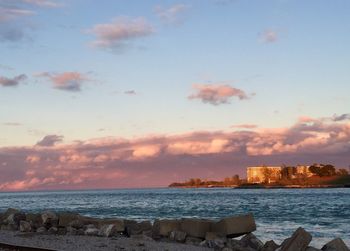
[154, 4, 189, 23]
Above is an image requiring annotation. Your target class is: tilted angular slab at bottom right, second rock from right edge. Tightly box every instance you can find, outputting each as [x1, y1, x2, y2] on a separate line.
[277, 227, 312, 251]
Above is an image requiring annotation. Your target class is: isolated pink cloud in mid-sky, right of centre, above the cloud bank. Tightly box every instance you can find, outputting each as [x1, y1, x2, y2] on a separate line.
[188, 84, 248, 105]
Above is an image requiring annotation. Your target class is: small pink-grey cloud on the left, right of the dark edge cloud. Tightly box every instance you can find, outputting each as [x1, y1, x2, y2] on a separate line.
[35, 72, 89, 92]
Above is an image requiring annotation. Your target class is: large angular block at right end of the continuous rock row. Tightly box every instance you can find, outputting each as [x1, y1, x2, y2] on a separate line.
[212, 214, 256, 238]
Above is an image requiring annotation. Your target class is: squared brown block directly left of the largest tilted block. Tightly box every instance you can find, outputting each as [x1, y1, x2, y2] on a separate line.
[180, 219, 214, 239]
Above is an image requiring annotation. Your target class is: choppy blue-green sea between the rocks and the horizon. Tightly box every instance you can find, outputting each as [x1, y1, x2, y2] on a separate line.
[0, 188, 350, 247]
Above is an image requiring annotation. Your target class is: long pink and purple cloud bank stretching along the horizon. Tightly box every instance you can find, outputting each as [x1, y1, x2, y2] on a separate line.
[0, 118, 350, 190]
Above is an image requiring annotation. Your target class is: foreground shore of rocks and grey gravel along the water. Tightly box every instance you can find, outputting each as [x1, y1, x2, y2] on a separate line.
[0, 208, 349, 251]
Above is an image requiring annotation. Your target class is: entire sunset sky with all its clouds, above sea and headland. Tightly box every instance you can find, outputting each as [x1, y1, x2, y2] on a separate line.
[0, 0, 350, 191]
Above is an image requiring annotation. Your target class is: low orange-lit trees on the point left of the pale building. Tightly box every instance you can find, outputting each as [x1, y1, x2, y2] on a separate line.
[169, 174, 242, 187]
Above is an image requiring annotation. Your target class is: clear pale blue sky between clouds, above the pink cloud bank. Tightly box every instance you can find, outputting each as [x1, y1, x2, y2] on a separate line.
[0, 0, 350, 145]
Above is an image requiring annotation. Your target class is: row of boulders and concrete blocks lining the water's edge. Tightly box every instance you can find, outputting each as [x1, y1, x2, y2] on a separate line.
[0, 208, 349, 251]
